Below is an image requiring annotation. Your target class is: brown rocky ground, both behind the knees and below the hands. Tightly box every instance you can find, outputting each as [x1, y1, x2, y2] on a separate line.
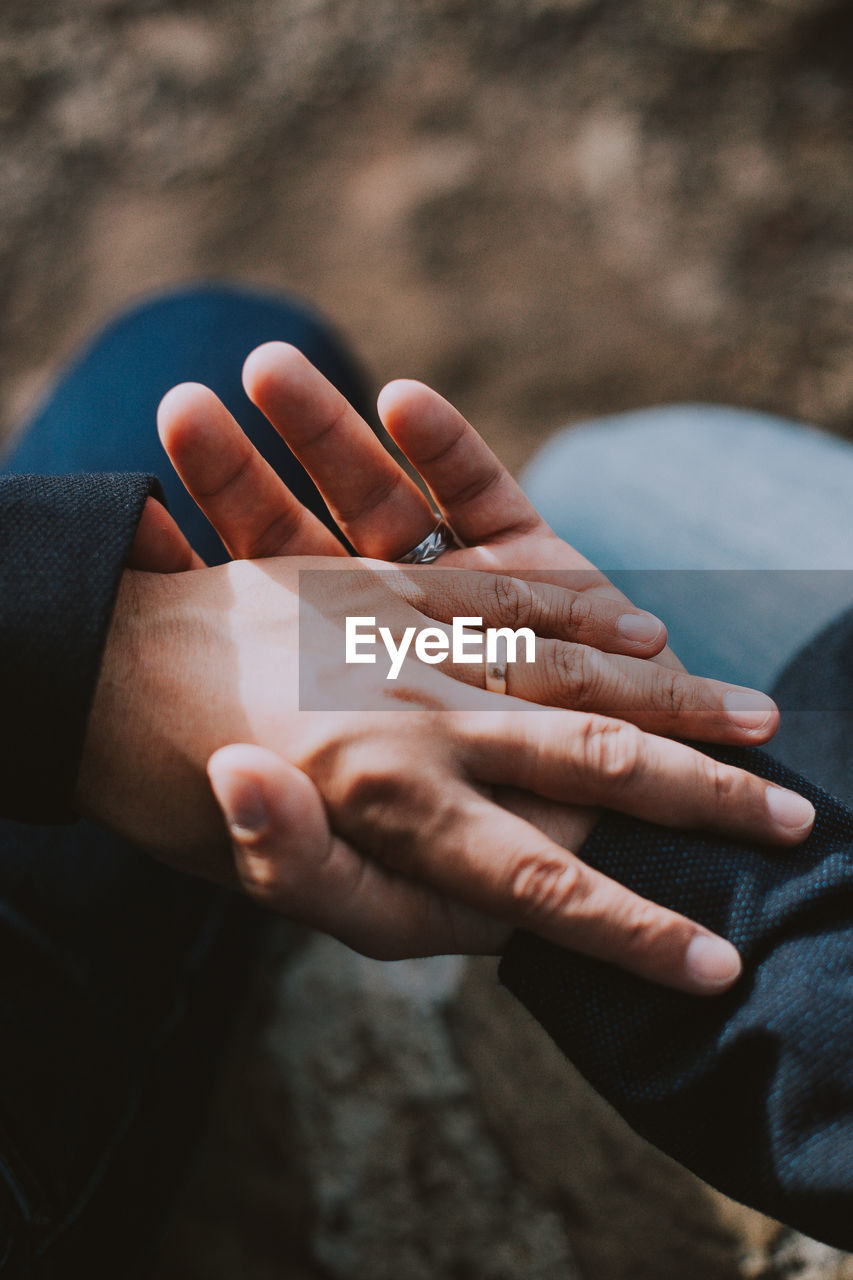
[0, 0, 853, 1280]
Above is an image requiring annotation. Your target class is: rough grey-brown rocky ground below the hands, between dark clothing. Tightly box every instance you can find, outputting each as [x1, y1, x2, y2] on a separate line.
[155, 937, 853, 1280]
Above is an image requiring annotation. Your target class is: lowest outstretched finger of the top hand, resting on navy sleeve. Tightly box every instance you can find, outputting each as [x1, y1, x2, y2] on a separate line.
[327, 762, 740, 995]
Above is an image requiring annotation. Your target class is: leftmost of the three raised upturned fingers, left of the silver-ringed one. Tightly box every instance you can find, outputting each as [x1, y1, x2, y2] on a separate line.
[158, 383, 346, 559]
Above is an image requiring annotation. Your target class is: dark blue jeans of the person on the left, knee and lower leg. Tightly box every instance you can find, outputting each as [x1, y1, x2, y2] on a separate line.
[0, 287, 368, 1280]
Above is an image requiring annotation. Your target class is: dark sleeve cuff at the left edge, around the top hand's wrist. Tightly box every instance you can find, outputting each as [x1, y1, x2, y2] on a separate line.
[0, 474, 160, 823]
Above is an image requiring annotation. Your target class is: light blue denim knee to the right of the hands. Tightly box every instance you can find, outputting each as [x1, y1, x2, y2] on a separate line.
[523, 404, 853, 689]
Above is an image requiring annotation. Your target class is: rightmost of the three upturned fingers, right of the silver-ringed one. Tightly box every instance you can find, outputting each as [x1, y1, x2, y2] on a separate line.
[378, 379, 545, 545]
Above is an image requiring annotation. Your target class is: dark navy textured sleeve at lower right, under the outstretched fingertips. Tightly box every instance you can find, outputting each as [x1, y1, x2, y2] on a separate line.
[501, 750, 853, 1249]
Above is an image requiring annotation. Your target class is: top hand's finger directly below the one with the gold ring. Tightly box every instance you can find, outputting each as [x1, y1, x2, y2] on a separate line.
[456, 703, 815, 845]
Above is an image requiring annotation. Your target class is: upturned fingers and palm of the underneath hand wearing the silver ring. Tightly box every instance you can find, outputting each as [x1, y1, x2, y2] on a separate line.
[159, 343, 680, 667]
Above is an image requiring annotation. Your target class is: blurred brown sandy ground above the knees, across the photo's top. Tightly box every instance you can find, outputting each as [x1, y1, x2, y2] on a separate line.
[0, 0, 853, 481]
